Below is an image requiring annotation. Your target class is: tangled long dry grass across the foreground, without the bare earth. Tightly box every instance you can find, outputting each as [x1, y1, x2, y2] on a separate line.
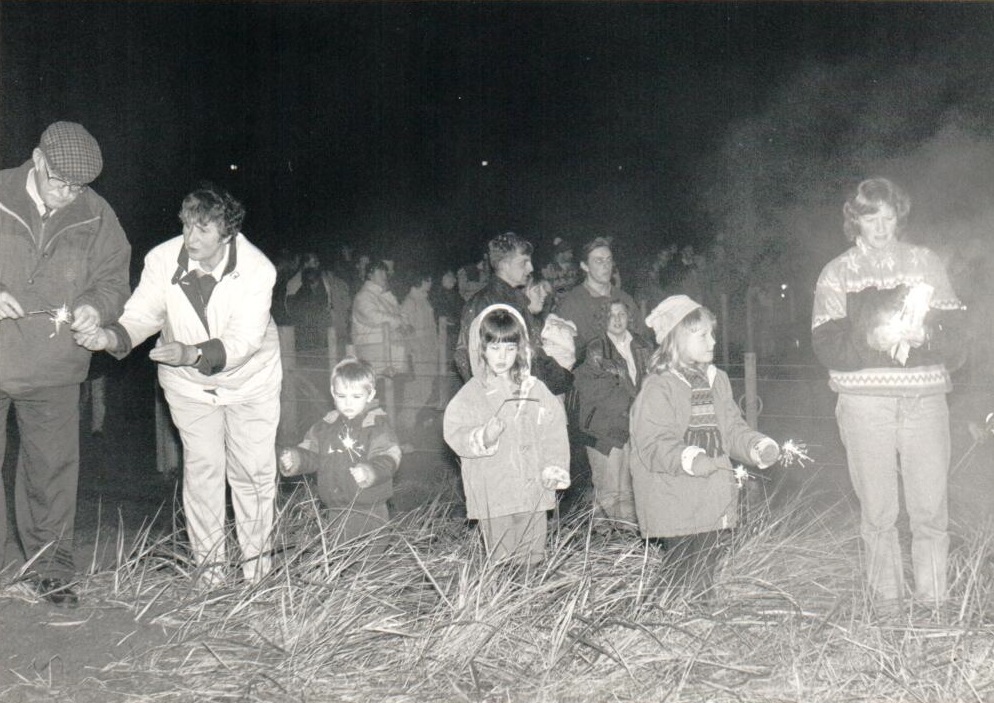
[0, 478, 994, 703]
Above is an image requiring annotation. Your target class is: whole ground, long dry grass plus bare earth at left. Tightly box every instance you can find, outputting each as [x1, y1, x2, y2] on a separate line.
[0, 366, 994, 703]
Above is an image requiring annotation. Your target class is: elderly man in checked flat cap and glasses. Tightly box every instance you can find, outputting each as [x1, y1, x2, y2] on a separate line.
[0, 122, 131, 607]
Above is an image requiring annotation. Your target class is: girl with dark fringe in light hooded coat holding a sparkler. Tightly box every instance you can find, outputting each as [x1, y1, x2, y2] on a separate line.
[444, 304, 570, 564]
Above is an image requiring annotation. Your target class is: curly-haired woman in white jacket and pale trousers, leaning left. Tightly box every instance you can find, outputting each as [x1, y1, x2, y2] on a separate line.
[77, 186, 282, 586]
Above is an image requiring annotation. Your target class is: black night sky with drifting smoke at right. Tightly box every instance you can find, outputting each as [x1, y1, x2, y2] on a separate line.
[0, 0, 994, 288]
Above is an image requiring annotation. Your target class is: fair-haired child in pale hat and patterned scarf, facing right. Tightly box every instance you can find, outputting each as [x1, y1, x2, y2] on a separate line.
[629, 295, 780, 592]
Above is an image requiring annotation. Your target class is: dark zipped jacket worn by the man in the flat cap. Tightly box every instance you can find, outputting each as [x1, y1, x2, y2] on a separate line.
[0, 161, 131, 392]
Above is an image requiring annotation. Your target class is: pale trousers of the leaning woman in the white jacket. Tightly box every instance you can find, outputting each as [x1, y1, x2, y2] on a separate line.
[166, 384, 280, 582]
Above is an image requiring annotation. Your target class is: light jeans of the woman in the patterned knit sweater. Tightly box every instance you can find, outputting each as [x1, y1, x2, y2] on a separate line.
[835, 394, 950, 603]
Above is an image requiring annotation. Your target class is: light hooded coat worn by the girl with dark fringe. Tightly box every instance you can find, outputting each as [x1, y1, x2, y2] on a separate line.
[444, 304, 569, 519]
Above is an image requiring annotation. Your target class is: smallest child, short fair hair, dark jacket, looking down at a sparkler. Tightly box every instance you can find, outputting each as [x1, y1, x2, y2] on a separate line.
[280, 357, 401, 542]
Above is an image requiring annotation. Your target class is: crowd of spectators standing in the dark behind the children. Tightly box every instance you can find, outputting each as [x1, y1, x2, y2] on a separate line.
[272, 233, 756, 440]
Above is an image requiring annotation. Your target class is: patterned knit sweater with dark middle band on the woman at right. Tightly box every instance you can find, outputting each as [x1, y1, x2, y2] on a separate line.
[811, 239, 966, 397]
